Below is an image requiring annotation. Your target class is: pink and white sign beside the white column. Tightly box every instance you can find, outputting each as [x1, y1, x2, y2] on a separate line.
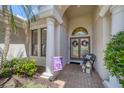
[53, 56, 63, 71]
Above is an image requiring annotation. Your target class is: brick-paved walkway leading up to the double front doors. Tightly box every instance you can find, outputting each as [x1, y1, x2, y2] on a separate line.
[31, 63, 104, 88]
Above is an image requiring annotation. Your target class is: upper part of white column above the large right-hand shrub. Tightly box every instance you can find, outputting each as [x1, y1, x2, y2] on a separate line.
[111, 5, 124, 35]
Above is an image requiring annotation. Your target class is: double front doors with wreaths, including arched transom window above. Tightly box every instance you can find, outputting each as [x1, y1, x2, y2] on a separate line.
[70, 27, 90, 60]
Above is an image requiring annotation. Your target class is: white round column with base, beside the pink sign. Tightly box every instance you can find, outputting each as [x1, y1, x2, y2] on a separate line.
[44, 18, 55, 77]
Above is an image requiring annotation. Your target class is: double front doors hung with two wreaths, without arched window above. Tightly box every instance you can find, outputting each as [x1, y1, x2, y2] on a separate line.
[70, 37, 90, 60]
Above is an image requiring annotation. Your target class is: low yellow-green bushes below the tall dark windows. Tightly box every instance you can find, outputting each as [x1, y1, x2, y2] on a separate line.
[0, 58, 37, 77]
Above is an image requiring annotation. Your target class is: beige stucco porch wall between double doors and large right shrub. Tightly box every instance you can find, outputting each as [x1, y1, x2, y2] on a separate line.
[93, 8, 111, 80]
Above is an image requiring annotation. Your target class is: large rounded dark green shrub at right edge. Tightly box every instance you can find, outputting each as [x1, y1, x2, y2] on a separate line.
[104, 31, 124, 87]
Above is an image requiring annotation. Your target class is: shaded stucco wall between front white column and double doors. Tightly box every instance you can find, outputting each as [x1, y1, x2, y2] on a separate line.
[55, 16, 68, 65]
